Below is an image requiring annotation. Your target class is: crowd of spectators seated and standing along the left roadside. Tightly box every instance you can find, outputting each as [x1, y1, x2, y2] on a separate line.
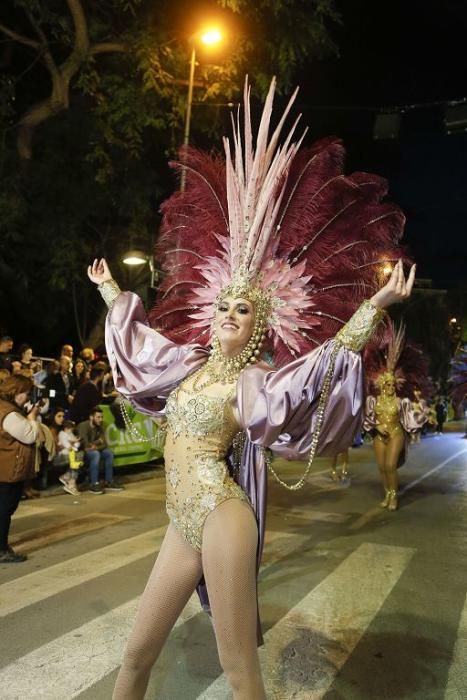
[0, 334, 122, 520]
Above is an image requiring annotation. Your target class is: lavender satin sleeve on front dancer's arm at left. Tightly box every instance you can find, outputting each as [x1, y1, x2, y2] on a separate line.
[105, 292, 208, 414]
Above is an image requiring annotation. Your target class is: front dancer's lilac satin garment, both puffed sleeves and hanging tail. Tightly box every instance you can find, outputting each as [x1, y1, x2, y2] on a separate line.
[106, 292, 363, 640]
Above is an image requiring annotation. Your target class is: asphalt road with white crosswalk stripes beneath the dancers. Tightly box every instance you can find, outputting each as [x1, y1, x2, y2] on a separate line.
[0, 433, 467, 700]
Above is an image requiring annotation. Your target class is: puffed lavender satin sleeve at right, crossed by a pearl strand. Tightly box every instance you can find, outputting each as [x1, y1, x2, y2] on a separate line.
[236, 340, 363, 459]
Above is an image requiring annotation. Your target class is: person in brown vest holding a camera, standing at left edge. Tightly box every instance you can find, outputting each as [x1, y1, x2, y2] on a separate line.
[0, 374, 42, 565]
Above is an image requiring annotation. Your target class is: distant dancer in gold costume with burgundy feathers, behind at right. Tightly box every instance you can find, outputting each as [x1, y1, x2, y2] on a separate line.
[363, 321, 432, 511]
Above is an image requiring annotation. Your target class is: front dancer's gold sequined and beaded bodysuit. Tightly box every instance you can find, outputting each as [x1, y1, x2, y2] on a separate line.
[164, 377, 248, 552]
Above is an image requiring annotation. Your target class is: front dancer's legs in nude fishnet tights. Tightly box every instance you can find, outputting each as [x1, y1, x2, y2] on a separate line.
[113, 499, 266, 700]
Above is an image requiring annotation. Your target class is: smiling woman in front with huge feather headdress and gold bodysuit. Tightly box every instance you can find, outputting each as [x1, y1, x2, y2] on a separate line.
[88, 81, 415, 700]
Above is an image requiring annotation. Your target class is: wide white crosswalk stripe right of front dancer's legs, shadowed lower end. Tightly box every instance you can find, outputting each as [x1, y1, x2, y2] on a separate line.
[198, 544, 415, 700]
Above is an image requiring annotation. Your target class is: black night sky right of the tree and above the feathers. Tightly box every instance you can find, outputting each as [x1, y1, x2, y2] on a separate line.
[300, 0, 467, 287]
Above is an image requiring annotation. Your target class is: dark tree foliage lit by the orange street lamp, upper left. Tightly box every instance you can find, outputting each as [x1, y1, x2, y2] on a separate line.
[0, 0, 339, 353]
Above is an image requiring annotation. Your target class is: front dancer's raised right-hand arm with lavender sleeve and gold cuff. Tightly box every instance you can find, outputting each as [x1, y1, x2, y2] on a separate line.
[236, 263, 415, 458]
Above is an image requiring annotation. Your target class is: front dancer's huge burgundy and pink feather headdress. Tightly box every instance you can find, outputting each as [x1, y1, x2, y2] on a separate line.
[150, 80, 405, 365]
